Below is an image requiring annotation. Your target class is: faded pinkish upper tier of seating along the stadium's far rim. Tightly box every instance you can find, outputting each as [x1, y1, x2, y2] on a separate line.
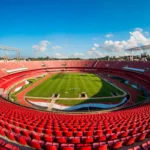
[0, 60, 150, 77]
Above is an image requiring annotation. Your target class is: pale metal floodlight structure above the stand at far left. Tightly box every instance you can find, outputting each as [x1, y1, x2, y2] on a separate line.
[0, 45, 20, 60]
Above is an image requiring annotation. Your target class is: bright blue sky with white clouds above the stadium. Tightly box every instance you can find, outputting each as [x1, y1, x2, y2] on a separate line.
[0, 0, 150, 58]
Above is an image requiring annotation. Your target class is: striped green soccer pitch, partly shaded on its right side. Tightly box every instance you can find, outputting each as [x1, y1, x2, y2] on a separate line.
[26, 73, 123, 98]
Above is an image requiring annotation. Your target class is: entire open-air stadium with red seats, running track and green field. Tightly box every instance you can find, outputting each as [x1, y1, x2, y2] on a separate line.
[0, 55, 150, 150]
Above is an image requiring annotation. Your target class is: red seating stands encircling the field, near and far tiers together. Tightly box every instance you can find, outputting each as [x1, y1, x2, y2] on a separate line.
[0, 60, 150, 150]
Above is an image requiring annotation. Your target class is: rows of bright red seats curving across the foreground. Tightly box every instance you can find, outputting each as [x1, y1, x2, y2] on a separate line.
[0, 98, 150, 150]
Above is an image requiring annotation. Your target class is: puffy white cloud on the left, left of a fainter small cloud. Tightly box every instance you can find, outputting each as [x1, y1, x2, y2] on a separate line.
[32, 40, 51, 52]
